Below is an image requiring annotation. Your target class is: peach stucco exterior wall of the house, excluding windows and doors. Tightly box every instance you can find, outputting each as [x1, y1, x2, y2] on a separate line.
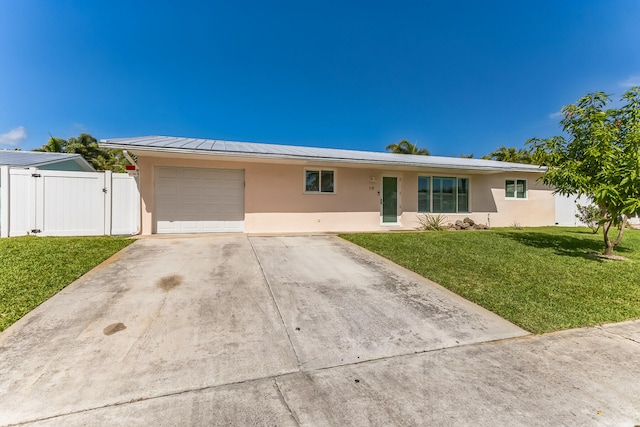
[137, 153, 555, 234]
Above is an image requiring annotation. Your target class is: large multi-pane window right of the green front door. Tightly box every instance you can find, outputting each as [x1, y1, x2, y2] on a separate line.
[418, 176, 469, 213]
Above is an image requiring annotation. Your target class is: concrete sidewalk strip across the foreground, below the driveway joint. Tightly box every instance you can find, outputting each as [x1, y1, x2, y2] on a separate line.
[6, 321, 640, 427]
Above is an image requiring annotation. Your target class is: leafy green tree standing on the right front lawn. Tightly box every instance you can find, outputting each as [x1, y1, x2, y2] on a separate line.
[527, 87, 640, 255]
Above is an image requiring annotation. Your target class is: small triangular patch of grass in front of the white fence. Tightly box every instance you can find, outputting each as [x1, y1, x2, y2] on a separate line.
[0, 236, 133, 332]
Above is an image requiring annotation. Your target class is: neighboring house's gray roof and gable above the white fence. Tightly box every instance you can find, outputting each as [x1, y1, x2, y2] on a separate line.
[0, 150, 96, 172]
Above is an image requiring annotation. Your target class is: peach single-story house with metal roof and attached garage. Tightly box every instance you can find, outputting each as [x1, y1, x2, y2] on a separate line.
[99, 136, 555, 234]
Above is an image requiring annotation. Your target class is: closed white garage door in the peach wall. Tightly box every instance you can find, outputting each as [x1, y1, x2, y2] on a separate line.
[155, 166, 244, 233]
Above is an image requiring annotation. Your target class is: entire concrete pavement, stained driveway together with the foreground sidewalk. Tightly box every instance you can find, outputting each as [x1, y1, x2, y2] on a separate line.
[0, 235, 640, 426]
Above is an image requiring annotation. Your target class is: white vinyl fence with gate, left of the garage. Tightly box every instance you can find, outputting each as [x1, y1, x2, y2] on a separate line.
[0, 166, 140, 237]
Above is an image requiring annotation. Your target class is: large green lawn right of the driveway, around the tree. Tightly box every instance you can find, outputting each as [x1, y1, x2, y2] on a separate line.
[341, 227, 640, 333]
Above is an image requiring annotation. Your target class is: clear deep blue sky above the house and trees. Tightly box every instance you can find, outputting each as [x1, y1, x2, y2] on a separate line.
[0, 0, 640, 157]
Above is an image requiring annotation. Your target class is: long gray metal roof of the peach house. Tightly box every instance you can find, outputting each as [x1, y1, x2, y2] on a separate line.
[99, 136, 544, 172]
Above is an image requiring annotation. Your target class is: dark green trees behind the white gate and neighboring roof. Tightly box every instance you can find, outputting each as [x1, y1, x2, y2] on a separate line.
[33, 133, 127, 172]
